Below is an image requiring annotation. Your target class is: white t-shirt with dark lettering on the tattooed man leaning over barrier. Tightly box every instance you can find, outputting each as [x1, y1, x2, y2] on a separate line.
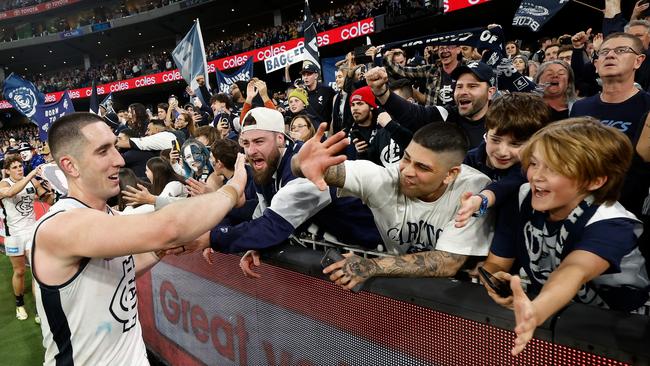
[339, 160, 494, 256]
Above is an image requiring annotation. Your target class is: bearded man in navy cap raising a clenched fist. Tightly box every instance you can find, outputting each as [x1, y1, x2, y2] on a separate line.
[366, 62, 496, 148]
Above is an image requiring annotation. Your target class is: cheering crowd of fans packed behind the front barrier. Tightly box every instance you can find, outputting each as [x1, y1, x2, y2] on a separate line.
[1, 0, 650, 354]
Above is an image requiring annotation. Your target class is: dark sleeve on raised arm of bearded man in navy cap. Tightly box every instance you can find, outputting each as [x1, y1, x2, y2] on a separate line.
[384, 92, 444, 133]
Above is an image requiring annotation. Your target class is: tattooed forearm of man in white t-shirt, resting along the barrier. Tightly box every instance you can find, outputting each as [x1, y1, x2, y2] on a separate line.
[375, 249, 467, 277]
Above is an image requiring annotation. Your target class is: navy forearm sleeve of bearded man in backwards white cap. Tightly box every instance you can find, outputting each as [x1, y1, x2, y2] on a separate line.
[210, 209, 294, 253]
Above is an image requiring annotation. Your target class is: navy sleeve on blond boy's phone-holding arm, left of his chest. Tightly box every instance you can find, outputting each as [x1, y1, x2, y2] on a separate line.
[490, 194, 522, 258]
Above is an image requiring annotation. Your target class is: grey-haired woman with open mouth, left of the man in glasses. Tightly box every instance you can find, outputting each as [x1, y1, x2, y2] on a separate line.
[535, 60, 577, 121]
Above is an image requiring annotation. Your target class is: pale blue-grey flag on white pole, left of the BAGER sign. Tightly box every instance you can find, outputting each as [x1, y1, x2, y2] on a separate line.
[172, 19, 210, 106]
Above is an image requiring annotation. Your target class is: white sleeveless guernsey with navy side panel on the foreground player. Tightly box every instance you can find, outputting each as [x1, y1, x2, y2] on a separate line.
[32, 198, 149, 366]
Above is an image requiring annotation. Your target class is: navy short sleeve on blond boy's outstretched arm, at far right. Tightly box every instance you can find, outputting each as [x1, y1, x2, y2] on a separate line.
[574, 218, 638, 273]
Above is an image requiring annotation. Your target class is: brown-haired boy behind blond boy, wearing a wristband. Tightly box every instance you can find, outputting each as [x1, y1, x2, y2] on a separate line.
[456, 93, 551, 227]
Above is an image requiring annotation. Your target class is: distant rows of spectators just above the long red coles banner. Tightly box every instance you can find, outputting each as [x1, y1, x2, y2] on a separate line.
[27, 0, 385, 93]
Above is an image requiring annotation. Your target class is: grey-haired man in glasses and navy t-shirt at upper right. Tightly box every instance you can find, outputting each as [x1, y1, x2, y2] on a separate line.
[570, 33, 650, 141]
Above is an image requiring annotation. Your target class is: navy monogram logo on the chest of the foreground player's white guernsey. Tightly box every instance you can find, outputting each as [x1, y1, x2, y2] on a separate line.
[110, 255, 138, 333]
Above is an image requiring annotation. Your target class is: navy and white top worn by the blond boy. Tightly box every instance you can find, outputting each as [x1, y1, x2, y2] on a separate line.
[490, 183, 650, 311]
